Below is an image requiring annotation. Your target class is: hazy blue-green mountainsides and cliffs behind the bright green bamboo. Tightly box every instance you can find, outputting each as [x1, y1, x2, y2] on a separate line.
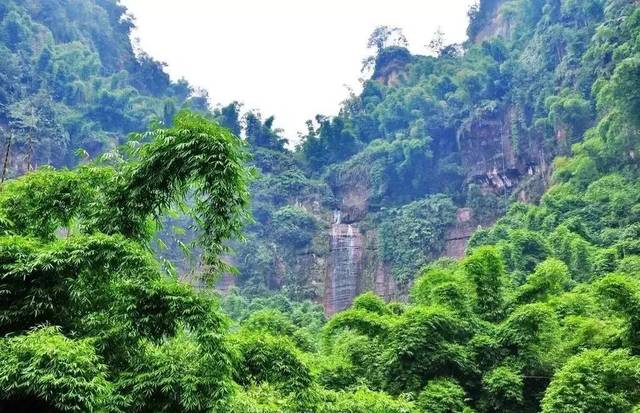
[0, 0, 634, 313]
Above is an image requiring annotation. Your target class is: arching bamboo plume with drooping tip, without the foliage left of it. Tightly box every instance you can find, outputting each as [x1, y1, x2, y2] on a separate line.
[99, 112, 251, 271]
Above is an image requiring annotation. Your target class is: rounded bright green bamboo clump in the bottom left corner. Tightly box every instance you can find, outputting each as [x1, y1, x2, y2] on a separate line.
[0, 327, 113, 412]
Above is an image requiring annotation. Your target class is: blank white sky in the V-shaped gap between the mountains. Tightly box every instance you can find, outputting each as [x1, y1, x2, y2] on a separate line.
[121, 0, 474, 141]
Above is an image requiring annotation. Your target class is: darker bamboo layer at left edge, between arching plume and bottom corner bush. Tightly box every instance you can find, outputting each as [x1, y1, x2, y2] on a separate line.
[0, 235, 159, 333]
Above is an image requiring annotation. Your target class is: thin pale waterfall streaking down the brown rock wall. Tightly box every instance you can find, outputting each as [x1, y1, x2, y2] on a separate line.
[324, 210, 362, 315]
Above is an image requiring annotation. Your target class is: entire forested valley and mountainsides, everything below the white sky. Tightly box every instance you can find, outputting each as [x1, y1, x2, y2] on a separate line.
[0, 0, 640, 413]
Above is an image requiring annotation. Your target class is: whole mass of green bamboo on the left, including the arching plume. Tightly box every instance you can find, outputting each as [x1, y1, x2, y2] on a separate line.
[0, 113, 248, 412]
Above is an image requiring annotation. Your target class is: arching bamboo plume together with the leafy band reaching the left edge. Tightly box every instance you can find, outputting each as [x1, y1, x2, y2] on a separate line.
[0, 112, 252, 280]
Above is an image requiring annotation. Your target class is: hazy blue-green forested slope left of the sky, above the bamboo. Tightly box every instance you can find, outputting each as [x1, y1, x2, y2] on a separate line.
[0, 0, 207, 174]
